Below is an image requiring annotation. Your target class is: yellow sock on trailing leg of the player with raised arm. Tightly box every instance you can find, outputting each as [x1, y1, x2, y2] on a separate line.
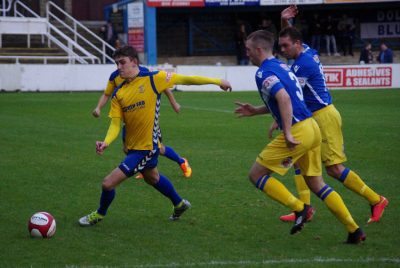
[340, 168, 380, 205]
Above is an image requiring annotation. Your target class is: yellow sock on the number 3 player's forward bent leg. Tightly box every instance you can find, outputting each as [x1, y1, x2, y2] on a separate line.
[256, 175, 304, 211]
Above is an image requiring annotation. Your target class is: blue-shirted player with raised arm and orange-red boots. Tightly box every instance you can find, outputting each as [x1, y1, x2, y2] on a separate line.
[279, 6, 389, 223]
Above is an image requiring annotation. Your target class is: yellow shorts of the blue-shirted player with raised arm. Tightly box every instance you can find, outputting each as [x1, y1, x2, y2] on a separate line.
[313, 104, 347, 167]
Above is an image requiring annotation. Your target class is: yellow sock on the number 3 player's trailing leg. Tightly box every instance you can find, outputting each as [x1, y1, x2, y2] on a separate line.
[318, 185, 358, 233]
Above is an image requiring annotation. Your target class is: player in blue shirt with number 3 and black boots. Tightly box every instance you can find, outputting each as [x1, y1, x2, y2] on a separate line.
[235, 30, 365, 244]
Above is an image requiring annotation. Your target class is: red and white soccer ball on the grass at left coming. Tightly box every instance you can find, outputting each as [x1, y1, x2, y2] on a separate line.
[28, 212, 56, 238]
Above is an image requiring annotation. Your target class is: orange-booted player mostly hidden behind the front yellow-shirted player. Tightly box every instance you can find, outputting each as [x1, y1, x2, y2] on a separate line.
[92, 65, 192, 179]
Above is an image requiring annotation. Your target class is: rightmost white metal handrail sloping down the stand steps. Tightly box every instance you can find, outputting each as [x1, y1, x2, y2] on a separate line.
[46, 1, 115, 63]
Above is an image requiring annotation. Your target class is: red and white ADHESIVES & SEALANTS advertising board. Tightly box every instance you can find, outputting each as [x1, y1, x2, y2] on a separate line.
[324, 65, 393, 88]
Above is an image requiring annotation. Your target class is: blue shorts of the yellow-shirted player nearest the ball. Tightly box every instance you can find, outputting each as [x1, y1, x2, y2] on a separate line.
[119, 148, 160, 177]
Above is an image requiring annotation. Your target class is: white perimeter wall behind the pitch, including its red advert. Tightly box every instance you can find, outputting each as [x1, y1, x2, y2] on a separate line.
[0, 64, 400, 91]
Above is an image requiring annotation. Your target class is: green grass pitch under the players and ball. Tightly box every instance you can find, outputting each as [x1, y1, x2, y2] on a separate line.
[0, 90, 400, 268]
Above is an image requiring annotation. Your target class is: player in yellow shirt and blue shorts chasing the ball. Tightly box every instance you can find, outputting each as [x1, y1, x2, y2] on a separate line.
[79, 46, 231, 226]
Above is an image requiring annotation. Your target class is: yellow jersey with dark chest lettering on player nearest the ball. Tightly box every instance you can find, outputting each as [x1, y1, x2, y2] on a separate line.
[109, 70, 177, 150]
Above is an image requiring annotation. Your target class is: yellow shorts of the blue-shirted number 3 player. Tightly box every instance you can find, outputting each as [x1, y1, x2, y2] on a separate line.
[256, 118, 322, 176]
